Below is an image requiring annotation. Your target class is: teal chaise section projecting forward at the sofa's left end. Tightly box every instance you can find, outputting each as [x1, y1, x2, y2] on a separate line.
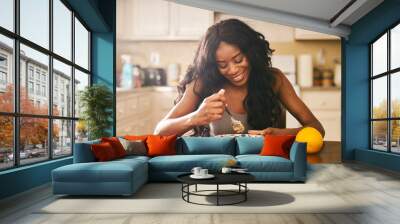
[52, 156, 148, 195]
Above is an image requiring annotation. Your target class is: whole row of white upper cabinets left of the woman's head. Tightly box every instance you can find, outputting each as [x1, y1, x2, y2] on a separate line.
[117, 0, 214, 41]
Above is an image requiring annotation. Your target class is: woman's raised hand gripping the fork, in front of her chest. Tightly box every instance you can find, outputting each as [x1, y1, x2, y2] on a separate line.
[192, 89, 226, 126]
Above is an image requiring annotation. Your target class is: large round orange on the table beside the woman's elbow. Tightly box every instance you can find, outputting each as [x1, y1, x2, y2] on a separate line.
[296, 127, 324, 154]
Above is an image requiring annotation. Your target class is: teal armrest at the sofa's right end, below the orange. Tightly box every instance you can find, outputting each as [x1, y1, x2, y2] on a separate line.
[290, 141, 307, 181]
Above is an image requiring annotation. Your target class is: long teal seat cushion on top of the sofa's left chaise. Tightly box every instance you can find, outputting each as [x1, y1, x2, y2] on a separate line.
[52, 159, 147, 182]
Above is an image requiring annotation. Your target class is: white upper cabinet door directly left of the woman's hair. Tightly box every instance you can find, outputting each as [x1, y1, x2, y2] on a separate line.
[170, 3, 214, 39]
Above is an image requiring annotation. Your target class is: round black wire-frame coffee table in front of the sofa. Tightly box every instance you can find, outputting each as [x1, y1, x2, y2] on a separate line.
[177, 173, 255, 206]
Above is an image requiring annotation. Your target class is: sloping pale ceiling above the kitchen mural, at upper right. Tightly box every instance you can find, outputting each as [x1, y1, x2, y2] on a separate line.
[168, 0, 383, 37]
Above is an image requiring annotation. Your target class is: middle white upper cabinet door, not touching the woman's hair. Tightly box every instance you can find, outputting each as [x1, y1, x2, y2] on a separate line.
[131, 0, 170, 39]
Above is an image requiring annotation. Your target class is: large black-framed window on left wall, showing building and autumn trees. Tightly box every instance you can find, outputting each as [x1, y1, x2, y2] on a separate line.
[0, 0, 91, 170]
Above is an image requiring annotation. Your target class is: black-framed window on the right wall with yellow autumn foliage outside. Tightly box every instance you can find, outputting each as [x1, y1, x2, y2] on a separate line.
[370, 24, 400, 153]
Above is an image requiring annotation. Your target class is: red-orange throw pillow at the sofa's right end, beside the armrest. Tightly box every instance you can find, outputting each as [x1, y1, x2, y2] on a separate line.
[260, 135, 296, 159]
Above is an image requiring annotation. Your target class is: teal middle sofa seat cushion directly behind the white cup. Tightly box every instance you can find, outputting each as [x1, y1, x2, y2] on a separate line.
[149, 154, 235, 172]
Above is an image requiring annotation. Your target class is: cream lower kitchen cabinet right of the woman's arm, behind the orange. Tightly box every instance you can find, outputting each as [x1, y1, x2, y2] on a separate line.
[301, 88, 341, 141]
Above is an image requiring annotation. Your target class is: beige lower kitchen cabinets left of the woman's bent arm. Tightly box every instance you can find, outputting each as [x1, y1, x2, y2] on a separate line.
[117, 87, 178, 136]
